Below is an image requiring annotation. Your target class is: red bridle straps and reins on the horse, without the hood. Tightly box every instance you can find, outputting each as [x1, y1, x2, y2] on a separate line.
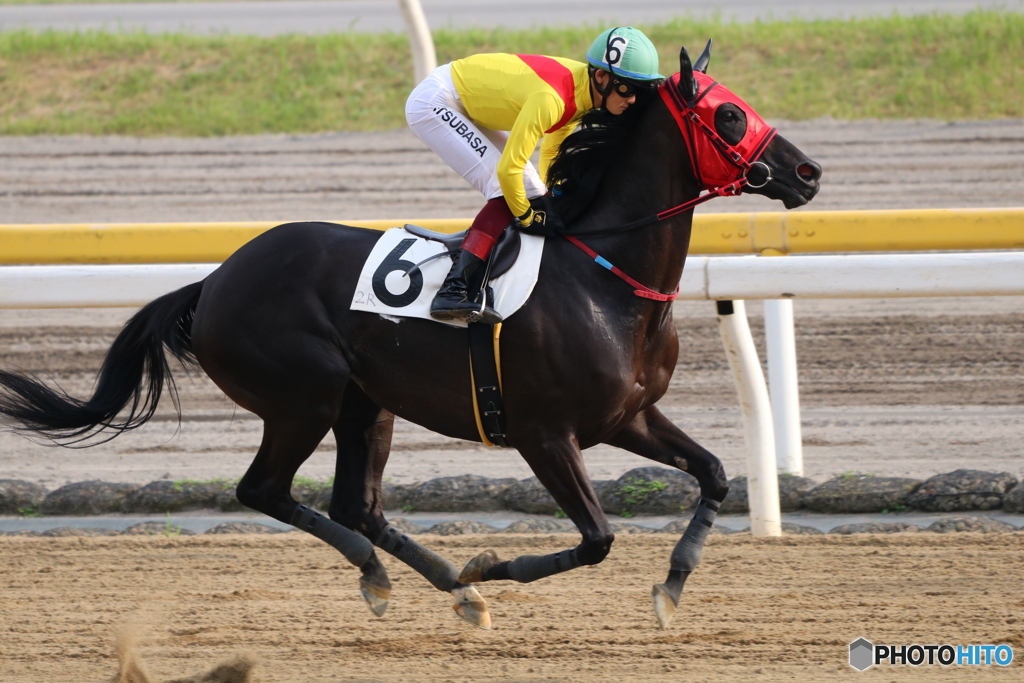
[561, 78, 774, 301]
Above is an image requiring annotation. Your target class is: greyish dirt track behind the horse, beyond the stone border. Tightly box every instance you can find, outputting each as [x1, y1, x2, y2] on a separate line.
[0, 120, 1024, 487]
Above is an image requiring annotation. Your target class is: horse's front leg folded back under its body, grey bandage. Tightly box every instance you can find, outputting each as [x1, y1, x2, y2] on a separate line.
[459, 434, 615, 584]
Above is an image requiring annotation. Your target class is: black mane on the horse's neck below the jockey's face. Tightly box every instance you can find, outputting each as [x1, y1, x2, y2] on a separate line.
[548, 91, 657, 225]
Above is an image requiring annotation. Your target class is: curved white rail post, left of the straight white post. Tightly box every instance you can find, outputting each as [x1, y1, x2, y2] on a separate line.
[715, 300, 782, 536]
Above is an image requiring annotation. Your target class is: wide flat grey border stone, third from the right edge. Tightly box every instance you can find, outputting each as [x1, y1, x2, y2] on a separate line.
[804, 474, 921, 514]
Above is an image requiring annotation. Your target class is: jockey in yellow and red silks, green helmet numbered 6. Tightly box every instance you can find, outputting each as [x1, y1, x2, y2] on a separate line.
[406, 27, 665, 324]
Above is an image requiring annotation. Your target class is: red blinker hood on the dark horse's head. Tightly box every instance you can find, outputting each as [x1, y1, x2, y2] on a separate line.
[658, 71, 777, 195]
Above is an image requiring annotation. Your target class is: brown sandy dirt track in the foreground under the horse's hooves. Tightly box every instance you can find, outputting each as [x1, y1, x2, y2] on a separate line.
[0, 532, 1024, 683]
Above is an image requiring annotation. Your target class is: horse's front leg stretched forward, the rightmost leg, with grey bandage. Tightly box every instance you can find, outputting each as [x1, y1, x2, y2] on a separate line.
[607, 405, 729, 629]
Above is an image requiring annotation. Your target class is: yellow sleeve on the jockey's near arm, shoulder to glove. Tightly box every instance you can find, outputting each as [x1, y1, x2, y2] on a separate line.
[498, 91, 565, 216]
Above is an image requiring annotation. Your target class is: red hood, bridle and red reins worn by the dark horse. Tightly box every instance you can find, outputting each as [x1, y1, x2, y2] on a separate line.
[564, 72, 778, 301]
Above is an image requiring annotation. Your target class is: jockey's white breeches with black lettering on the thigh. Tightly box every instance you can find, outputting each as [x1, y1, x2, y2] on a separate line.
[406, 65, 548, 200]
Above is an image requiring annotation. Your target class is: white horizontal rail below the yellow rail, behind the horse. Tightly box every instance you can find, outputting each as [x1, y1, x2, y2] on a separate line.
[0, 252, 1024, 308]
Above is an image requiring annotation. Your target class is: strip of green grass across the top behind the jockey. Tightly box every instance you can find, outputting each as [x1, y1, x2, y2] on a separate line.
[0, 11, 1024, 136]
